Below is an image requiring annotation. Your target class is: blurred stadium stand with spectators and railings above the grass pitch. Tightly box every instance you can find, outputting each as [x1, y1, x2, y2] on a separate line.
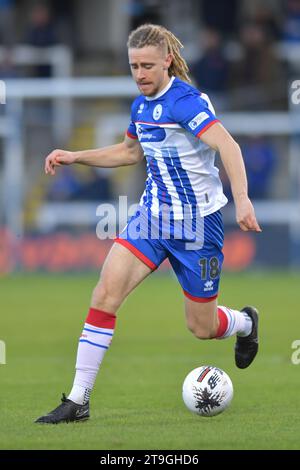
[0, 0, 300, 274]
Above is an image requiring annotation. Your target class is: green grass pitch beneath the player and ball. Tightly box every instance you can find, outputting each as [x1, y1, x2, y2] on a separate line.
[0, 272, 300, 450]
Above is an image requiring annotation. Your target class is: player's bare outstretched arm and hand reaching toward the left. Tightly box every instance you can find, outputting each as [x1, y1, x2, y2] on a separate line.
[45, 136, 144, 175]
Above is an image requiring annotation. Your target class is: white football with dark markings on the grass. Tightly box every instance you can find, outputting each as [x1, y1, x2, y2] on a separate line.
[182, 366, 233, 416]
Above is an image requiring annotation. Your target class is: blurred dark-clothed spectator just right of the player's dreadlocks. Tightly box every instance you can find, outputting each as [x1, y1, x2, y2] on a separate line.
[190, 29, 229, 110]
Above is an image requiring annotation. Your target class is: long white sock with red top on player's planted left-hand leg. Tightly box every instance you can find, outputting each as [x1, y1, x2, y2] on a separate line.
[68, 309, 116, 405]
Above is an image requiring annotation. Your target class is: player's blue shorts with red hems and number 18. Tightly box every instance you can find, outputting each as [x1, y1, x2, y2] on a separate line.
[115, 206, 224, 302]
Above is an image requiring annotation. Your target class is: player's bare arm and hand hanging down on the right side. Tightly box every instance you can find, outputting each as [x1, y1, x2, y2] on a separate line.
[200, 122, 262, 232]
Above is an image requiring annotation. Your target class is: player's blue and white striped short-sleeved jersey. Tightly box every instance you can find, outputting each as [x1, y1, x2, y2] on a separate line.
[127, 77, 227, 219]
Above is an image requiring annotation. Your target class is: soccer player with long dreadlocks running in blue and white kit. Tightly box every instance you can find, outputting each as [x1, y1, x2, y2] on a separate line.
[36, 24, 261, 424]
